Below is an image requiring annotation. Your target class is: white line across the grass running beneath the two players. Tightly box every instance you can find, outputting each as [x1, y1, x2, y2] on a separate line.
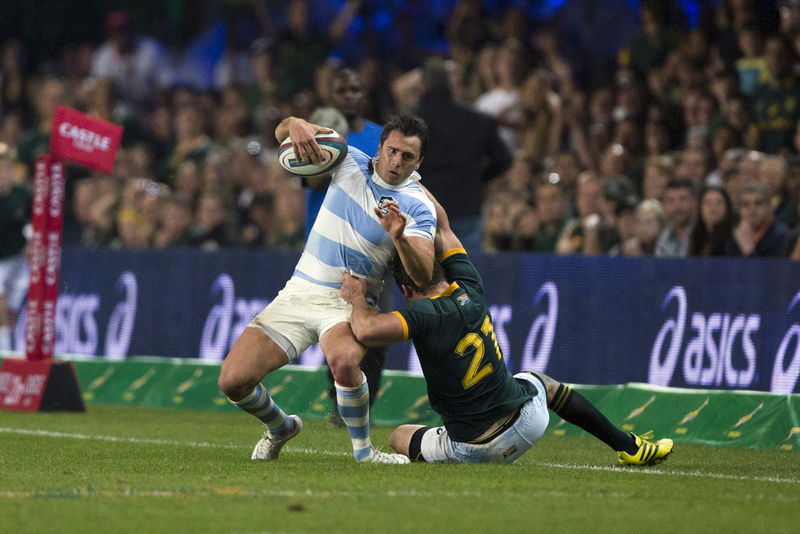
[0, 427, 800, 490]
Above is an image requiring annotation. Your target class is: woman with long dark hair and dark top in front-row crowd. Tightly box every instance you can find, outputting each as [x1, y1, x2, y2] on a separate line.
[689, 186, 740, 256]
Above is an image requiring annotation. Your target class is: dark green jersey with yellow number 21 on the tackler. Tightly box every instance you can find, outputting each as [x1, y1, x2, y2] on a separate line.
[393, 249, 536, 442]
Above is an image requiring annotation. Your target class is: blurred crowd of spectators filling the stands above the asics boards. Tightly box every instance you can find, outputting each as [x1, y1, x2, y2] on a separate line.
[0, 0, 800, 259]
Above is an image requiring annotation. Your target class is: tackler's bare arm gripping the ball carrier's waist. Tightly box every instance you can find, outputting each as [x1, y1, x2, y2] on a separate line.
[341, 274, 406, 347]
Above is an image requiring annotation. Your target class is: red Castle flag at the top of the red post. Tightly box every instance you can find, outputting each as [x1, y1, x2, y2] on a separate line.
[50, 106, 122, 172]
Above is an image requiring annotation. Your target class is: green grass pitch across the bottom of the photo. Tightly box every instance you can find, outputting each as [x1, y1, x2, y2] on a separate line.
[0, 405, 800, 533]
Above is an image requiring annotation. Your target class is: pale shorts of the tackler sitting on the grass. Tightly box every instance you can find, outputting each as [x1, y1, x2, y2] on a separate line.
[420, 373, 550, 464]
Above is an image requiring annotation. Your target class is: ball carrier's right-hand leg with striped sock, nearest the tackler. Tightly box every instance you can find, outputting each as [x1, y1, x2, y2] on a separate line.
[319, 323, 408, 464]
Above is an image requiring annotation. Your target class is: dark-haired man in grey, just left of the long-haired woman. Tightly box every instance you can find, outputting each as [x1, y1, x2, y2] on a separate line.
[656, 179, 697, 258]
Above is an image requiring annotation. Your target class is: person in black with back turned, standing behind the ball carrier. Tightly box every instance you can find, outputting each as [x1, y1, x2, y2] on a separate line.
[416, 59, 511, 251]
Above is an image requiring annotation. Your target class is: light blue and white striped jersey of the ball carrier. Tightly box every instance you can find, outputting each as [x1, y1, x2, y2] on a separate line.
[293, 146, 436, 298]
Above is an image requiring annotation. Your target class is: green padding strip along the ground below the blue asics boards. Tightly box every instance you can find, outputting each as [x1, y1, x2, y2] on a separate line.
[1, 357, 800, 450]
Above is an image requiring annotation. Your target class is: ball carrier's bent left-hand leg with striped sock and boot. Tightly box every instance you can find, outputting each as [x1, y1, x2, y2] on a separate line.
[217, 328, 303, 460]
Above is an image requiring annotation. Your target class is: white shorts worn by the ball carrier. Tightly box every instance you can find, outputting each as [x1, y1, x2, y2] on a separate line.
[247, 278, 353, 362]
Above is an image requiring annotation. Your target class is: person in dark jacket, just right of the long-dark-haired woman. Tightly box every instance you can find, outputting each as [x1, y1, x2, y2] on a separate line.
[733, 181, 789, 257]
